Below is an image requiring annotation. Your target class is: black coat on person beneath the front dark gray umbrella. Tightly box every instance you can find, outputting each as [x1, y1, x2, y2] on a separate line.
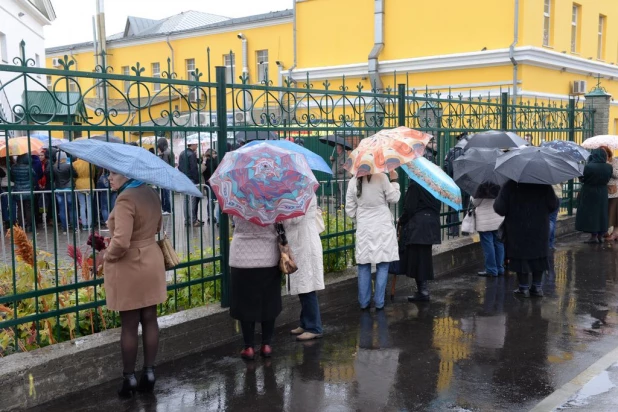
[494, 180, 560, 260]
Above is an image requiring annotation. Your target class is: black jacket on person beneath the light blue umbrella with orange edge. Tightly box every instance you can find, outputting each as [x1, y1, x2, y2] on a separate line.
[398, 180, 441, 245]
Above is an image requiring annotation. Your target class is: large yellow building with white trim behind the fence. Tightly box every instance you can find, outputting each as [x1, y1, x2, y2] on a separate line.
[47, 0, 618, 134]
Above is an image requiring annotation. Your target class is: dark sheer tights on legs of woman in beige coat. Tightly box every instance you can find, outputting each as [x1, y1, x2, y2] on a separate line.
[120, 306, 159, 373]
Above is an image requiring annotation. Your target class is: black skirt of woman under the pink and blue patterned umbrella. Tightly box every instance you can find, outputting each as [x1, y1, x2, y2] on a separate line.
[230, 266, 281, 322]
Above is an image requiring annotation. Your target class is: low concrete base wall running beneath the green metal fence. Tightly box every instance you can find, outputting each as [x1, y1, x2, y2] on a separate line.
[0, 217, 575, 411]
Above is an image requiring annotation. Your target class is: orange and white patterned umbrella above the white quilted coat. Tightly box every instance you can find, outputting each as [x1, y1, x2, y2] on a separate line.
[343, 126, 432, 177]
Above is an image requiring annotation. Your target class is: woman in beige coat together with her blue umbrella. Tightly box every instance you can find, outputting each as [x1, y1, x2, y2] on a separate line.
[60, 139, 202, 397]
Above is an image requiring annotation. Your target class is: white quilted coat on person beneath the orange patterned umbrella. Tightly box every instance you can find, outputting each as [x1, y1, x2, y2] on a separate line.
[345, 173, 401, 264]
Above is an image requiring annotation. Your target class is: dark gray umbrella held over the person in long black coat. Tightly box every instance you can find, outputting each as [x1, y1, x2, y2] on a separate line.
[496, 147, 584, 185]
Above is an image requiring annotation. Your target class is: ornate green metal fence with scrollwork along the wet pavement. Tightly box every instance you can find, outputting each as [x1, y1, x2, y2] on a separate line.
[0, 44, 592, 356]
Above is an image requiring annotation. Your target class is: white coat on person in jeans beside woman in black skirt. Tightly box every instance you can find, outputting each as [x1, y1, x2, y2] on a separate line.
[283, 195, 324, 295]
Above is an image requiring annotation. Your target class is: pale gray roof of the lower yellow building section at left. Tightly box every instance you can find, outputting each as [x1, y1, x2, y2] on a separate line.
[45, 10, 293, 54]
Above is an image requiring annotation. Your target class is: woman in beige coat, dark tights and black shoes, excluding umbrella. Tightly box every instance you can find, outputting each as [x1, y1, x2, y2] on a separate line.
[103, 173, 167, 396]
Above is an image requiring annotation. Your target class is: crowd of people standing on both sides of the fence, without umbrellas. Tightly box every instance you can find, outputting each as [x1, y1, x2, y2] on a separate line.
[14, 134, 596, 396]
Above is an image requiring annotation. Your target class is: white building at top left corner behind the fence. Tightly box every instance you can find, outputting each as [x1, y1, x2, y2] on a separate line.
[0, 0, 56, 130]
